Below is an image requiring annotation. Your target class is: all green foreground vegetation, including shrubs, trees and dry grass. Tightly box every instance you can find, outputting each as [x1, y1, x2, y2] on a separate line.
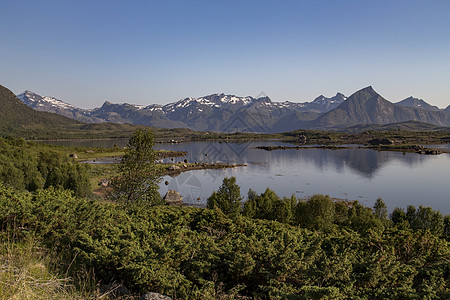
[0, 131, 450, 299]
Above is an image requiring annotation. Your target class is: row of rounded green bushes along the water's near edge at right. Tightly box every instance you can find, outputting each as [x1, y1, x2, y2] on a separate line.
[211, 177, 450, 239]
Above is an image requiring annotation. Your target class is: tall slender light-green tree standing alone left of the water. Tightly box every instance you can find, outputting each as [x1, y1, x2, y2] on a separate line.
[111, 129, 162, 205]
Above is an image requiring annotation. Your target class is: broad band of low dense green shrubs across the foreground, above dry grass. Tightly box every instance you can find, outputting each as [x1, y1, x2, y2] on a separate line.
[0, 182, 450, 299]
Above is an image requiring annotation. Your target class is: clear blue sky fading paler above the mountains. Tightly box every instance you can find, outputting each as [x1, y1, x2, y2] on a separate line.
[0, 0, 450, 108]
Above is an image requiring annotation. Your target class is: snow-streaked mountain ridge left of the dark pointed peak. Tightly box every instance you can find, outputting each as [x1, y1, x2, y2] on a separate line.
[18, 91, 346, 132]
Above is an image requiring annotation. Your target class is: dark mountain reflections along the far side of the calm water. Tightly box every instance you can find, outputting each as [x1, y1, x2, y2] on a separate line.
[157, 142, 427, 179]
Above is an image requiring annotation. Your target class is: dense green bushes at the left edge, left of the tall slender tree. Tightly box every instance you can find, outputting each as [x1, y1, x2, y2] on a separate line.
[0, 138, 91, 196]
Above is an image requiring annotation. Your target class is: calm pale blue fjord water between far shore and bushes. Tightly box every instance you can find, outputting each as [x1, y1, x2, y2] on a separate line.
[155, 142, 450, 214]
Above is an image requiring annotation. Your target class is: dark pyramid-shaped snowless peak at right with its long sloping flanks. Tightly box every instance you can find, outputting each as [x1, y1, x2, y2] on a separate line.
[306, 86, 450, 130]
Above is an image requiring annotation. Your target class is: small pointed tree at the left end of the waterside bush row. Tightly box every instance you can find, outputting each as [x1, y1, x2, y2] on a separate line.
[207, 176, 243, 217]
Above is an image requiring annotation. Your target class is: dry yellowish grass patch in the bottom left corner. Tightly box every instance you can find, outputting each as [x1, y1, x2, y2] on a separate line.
[0, 236, 138, 300]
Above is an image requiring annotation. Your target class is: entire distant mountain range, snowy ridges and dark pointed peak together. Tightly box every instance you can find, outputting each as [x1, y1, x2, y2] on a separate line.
[13, 86, 450, 132]
